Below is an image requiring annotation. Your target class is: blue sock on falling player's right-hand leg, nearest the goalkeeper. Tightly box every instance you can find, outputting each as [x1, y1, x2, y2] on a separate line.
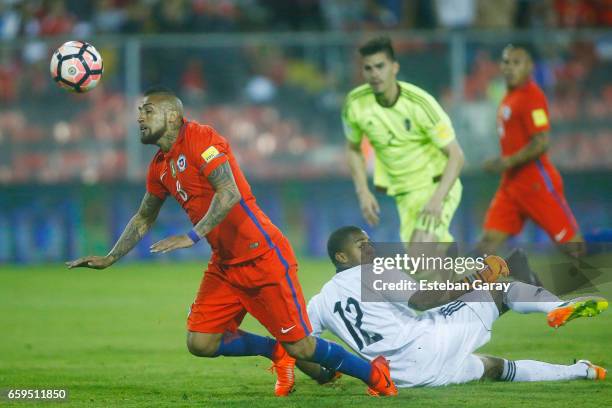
[310, 337, 372, 384]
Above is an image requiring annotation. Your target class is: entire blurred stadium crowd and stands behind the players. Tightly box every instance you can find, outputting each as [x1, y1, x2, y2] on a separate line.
[0, 0, 612, 183]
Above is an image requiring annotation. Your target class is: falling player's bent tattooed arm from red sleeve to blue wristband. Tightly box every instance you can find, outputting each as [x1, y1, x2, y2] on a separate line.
[194, 162, 241, 237]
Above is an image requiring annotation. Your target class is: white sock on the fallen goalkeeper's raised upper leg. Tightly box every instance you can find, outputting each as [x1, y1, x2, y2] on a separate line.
[504, 282, 563, 313]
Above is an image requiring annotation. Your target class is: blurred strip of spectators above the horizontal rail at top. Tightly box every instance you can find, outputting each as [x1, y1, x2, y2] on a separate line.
[0, 0, 612, 39]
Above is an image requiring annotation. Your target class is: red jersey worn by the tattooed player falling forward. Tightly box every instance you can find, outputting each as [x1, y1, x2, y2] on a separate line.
[147, 122, 282, 264]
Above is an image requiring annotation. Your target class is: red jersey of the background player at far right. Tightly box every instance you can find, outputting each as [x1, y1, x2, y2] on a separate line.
[497, 80, 560, 184]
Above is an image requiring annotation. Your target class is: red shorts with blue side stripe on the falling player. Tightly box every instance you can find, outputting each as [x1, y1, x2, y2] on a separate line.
[187, 237, 312, 342]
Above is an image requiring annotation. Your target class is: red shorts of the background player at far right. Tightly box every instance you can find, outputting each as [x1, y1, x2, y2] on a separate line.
[484, 179, 578, 243]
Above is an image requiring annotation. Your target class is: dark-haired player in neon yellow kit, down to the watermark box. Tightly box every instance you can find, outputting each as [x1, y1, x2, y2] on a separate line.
[342, 37, 464, 242]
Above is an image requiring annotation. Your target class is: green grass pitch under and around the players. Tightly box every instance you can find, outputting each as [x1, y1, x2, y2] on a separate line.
[0, 261, 612, 408]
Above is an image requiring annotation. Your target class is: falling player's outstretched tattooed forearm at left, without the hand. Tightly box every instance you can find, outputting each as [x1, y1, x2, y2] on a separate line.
[106, 193, 164, 263]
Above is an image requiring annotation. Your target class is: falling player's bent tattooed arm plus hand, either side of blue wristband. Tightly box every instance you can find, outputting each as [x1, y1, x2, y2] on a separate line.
[151, 162, 240, 253]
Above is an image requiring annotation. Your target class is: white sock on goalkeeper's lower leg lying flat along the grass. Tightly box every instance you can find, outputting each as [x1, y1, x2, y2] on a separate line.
[500, 360, 588, 382]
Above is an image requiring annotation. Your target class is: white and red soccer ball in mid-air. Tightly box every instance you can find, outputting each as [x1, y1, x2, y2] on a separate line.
[50, 41, 104, 93]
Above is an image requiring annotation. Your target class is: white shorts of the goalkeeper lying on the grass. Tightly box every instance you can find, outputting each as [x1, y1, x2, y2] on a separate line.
[392, 291, 499, 387]
